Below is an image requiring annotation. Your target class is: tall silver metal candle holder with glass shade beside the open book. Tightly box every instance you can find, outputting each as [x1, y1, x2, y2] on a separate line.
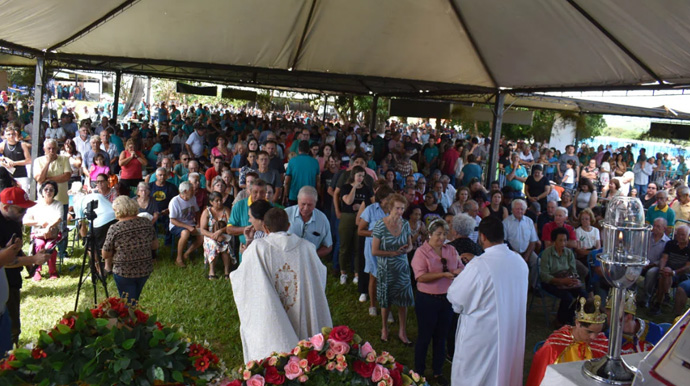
[582, 197, 651, 385]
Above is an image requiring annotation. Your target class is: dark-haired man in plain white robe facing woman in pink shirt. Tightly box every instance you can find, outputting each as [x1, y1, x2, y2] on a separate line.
[447, 217, 529, 386]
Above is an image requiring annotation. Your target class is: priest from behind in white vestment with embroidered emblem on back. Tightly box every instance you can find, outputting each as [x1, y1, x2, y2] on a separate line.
[230, 208, 333, 363]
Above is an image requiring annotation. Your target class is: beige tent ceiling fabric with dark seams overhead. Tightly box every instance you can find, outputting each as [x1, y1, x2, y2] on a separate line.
[0, 0, 690, 95]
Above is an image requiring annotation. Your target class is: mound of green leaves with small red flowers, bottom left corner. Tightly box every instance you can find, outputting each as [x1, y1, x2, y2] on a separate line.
[0, 298, 226, 386]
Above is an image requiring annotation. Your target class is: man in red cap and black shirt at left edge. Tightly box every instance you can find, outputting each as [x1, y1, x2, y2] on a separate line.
[0, 186, 51, 356]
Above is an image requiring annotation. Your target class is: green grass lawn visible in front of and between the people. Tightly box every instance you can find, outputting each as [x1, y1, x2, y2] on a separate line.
[14, 241, 670, 379]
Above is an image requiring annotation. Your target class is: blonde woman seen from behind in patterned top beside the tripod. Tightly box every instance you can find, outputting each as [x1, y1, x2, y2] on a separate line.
[102, 196, 158, 303]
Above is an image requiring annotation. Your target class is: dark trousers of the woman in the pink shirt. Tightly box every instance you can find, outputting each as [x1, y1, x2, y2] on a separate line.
[414, 292, 453, 375]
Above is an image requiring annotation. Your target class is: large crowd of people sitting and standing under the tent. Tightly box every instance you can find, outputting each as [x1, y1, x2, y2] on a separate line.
[0, 94, 690, 384]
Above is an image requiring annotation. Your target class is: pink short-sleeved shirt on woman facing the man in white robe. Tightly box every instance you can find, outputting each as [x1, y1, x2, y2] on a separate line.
[411, 242, 465, 295]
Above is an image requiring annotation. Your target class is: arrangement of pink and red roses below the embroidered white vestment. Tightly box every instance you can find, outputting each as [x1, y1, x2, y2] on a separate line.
[226, 326, 426, 386]
